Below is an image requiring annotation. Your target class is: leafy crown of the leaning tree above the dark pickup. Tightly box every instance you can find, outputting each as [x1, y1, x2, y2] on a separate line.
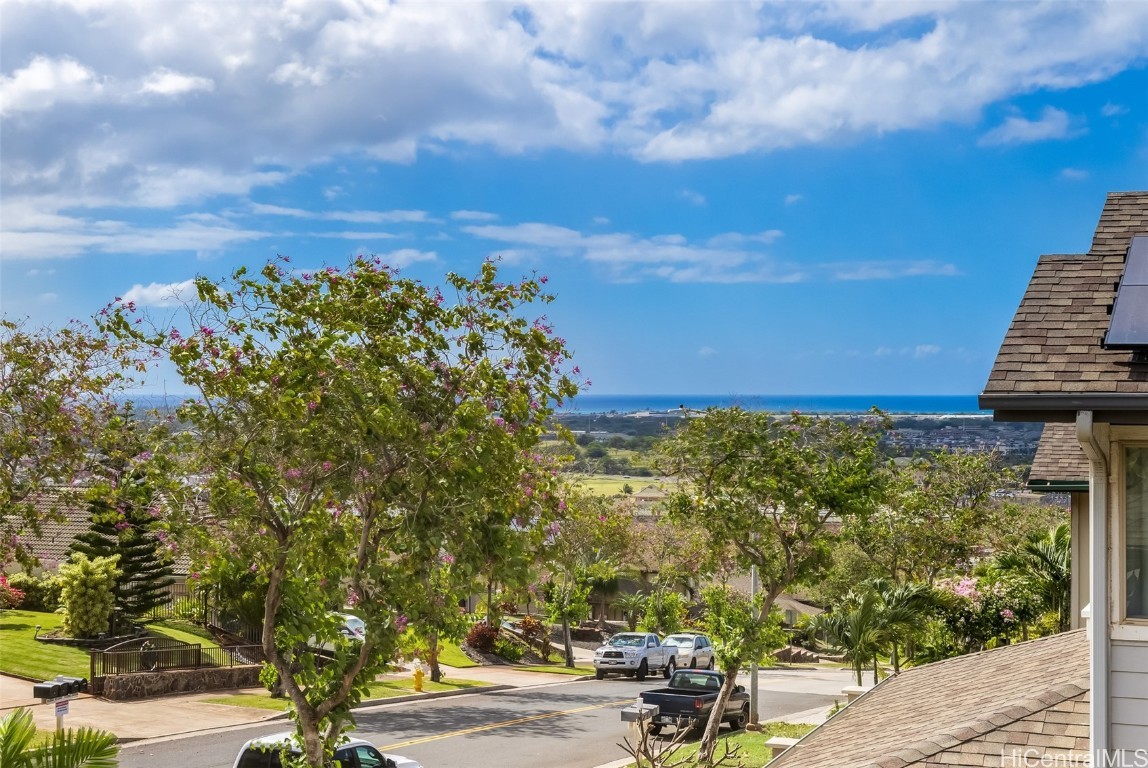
[661, 408, 885, 616]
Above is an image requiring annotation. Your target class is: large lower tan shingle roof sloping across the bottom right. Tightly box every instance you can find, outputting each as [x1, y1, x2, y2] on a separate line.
[769, 629, 1088, 768]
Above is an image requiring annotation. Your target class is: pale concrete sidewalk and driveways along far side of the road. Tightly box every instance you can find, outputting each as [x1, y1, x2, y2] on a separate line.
[0, 665, 592, 742]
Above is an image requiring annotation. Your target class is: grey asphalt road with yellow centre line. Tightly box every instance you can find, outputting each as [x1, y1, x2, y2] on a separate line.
[119, 678, 833, 768]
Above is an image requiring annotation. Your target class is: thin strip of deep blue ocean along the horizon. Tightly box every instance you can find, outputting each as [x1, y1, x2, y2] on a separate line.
[559, 395, 988, 416]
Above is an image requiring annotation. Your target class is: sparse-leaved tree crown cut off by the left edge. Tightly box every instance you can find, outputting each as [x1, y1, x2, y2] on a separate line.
[0, 318, 135, 568]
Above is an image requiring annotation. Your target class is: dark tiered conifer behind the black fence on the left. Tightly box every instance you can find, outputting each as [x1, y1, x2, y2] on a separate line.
[70, 405, 174, 619]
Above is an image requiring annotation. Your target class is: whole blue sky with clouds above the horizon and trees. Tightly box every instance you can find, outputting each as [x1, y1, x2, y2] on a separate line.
[0, 0, 1148, 394]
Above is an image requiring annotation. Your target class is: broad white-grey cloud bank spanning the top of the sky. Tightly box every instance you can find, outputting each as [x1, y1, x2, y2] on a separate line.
[0, 0, 1148, 225]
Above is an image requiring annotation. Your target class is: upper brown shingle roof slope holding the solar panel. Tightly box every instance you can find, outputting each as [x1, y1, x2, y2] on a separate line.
[982, 192, 1148, 408]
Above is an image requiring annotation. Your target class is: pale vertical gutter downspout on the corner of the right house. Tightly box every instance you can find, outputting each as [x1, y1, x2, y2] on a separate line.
[1076, 411, 1109, 766]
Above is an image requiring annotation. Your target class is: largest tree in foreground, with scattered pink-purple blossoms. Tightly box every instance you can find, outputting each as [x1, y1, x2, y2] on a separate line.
[108, 257, 576, 768]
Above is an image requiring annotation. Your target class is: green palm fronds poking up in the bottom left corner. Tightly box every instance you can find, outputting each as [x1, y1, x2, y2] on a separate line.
[0, 708, 119, 768]
